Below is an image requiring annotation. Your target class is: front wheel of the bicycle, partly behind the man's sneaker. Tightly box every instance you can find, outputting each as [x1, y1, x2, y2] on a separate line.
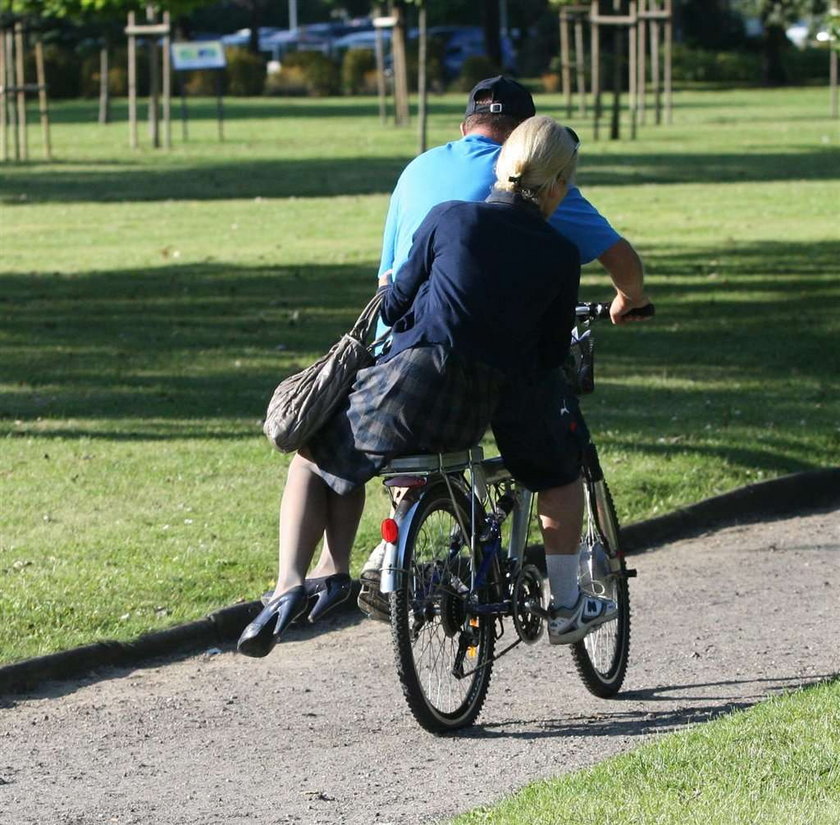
[572, 470, 630, 699]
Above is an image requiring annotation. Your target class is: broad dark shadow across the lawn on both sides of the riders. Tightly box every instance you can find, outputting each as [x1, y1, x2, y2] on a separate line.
[0, 242, 840, 471]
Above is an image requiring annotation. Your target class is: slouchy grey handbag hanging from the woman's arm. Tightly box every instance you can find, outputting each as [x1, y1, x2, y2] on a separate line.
[263, 289, 385, 453]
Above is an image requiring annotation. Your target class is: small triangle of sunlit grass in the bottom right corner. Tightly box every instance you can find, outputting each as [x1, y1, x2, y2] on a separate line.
[452, 681, 840, 825]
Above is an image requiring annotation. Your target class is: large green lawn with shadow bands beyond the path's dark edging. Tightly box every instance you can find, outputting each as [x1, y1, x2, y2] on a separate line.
[0, 89, 840, 662]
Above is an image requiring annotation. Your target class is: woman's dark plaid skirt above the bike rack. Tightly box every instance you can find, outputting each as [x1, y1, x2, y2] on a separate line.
[306, 345, 504, 494]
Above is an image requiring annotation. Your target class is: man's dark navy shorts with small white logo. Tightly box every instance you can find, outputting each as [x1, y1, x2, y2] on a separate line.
[492, 369, 589, 492]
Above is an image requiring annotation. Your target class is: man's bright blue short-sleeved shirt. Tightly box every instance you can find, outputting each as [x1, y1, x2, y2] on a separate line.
[379, 135, 621, 275]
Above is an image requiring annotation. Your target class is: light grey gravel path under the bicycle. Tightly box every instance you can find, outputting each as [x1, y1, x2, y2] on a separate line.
[0, 511, 840, 825]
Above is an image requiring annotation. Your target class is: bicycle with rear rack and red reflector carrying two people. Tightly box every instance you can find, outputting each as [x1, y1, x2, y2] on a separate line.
[380, 303, 653, 733]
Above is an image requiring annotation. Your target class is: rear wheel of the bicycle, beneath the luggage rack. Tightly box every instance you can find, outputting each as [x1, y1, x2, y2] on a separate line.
[390, 482, 496, 733]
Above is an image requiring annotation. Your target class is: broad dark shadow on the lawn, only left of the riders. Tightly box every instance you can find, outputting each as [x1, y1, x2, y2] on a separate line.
[0, 264, 375, 438]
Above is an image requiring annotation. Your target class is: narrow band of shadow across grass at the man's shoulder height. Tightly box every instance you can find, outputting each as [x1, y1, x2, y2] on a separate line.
[0, 147, 840, 206]
